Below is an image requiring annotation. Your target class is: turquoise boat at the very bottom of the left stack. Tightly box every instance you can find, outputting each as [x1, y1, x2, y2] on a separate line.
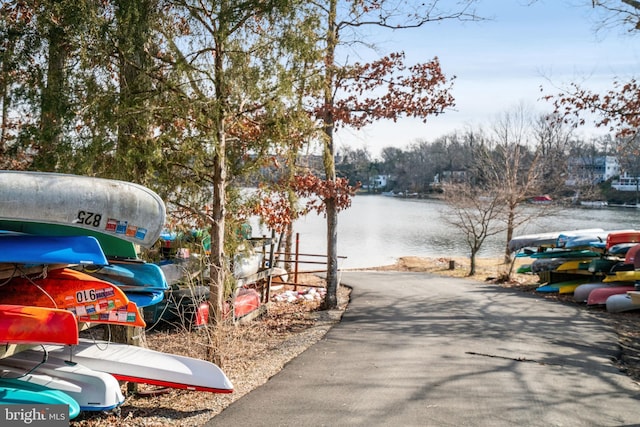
[0, 378, 80, 419]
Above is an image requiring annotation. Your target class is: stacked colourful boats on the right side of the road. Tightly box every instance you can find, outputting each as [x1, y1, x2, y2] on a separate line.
[509, 228, 640, 313]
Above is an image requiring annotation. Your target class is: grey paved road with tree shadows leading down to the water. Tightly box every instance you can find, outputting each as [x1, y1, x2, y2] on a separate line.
[207, 272, 640, 427]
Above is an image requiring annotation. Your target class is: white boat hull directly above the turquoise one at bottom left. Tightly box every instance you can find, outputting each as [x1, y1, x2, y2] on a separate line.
[0, 351, 125, 411]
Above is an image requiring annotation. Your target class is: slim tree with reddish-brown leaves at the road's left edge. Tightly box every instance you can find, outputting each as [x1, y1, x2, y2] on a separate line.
[309, 0, 477, 308]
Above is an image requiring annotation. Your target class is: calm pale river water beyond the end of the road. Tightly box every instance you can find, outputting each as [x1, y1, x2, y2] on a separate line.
[254, 195, 640, 268]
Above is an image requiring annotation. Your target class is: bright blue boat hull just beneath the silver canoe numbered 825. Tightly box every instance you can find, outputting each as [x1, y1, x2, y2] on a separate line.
[0, 234, 109, 265]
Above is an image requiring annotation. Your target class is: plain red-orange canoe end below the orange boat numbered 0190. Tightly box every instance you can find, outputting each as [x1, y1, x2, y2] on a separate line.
[0, 304, 78, 344]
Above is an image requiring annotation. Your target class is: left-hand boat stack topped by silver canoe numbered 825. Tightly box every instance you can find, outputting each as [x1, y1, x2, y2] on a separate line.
[0, 171, 233, 419]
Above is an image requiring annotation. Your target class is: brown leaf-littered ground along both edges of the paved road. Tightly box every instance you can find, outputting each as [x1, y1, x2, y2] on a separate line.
[70, 256, 640, 427]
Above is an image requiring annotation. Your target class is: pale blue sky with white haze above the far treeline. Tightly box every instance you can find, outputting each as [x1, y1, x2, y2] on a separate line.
[336, 0, 640, 157]
